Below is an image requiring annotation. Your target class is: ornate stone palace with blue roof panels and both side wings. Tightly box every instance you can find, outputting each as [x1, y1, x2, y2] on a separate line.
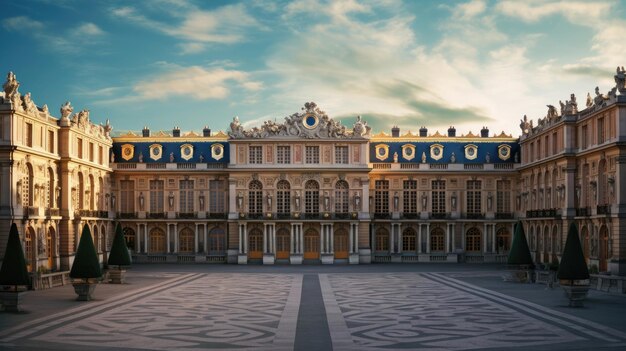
[0, 68, 626, 275]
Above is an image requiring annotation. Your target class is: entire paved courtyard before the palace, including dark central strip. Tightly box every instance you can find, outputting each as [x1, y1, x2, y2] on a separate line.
[0, 265, 626, 350]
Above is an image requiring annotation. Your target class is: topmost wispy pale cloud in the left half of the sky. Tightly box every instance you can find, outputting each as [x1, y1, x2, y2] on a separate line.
[111, 2, 262, 44]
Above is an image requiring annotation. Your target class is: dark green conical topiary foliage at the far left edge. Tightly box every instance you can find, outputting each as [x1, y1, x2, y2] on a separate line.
[0, 223, 30, 291]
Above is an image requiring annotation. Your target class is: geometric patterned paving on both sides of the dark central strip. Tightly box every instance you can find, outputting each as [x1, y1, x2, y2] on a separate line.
[0, 273, 626, 350]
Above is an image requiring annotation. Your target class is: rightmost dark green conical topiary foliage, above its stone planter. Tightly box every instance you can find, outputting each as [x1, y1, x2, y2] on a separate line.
[557, 222, 589, 285]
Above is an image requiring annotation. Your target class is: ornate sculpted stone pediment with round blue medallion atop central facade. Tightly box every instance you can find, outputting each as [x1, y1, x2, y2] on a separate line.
[228, 102, 371, 139]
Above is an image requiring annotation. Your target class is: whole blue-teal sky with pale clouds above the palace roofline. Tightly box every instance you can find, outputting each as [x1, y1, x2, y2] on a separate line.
[0, 0, 626, 137]
